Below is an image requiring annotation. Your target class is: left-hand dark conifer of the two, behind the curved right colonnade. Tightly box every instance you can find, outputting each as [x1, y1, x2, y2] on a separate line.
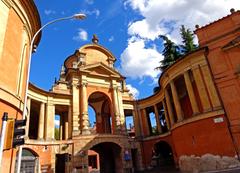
[156, 35, 181, 71]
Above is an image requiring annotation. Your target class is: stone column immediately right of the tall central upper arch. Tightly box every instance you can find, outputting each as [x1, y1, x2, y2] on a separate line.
[113, 86, 121, 133]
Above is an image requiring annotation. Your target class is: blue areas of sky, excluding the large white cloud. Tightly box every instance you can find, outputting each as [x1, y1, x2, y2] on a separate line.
[30, 0, 155, 97]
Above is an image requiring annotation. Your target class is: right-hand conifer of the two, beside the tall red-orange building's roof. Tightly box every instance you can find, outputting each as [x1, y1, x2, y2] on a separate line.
[180, 25, 197, 55]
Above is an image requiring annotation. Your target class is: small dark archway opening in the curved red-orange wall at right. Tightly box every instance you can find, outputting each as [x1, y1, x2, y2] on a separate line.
[153, 141, 174, 168]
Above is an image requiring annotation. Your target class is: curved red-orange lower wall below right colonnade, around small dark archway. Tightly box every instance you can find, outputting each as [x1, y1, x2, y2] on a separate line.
[142, 115, 236, 167]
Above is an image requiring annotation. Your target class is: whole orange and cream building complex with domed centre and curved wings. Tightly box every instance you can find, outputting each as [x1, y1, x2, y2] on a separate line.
[0, 0, 240, 173]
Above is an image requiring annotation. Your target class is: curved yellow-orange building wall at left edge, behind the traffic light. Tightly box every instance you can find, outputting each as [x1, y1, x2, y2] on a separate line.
[0, 0, 40, 172]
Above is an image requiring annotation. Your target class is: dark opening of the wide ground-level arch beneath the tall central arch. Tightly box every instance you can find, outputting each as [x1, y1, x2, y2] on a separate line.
[88, 142, 122, 173]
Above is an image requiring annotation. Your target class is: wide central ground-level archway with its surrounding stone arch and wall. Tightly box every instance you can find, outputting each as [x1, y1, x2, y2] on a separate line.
[73, 134, 132, 173]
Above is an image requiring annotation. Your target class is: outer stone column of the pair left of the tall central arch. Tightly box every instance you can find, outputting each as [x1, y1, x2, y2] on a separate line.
[69, 78, 80, 136]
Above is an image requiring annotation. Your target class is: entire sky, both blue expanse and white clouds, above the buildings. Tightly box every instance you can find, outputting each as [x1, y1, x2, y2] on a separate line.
[30, 0, 240, 98]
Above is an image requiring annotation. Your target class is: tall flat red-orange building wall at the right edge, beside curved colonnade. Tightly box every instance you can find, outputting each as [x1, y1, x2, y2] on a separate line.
[196, 9, 240, 153]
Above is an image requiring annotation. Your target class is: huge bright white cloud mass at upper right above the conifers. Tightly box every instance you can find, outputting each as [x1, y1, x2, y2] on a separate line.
[120, 0, 240, 81]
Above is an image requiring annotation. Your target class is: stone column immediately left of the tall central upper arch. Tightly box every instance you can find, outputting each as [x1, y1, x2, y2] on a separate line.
[81, 82, 90, 135]
